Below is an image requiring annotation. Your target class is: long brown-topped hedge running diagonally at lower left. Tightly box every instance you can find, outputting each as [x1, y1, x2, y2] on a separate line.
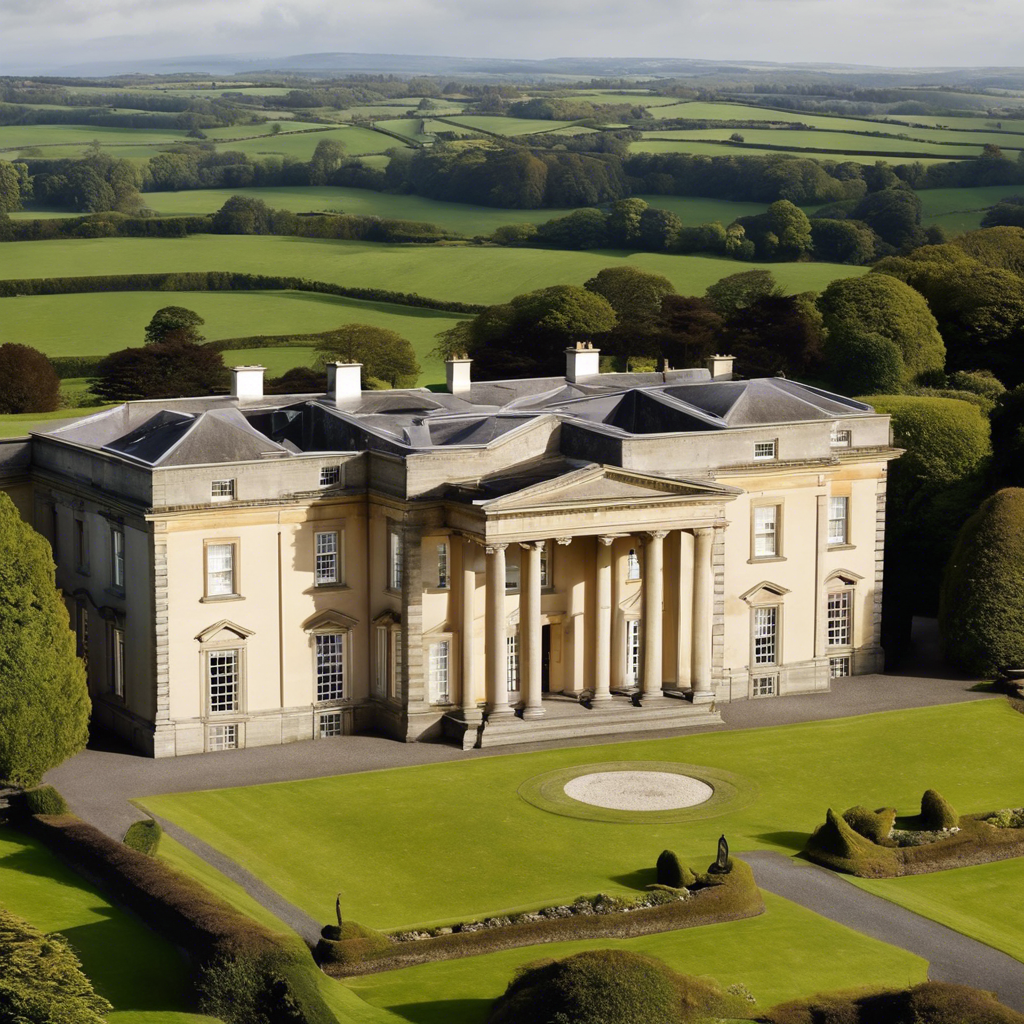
[22, 815, 337, 1024]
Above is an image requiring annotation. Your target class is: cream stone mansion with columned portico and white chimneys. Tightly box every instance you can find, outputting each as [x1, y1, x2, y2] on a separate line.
[0, 346, 900, 757]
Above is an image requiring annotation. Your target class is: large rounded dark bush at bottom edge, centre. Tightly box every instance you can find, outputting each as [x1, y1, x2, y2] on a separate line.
[487, 949, 751, 1024]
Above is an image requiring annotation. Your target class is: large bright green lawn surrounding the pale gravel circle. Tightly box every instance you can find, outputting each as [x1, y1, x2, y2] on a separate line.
[142, 700, 1024, 928]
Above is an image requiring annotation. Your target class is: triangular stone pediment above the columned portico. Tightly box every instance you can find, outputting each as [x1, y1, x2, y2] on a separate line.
[478, 466, 740, 512]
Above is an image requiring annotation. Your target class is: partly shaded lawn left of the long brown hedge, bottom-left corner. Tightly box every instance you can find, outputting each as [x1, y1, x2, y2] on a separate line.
[0, 827, 213, 1024]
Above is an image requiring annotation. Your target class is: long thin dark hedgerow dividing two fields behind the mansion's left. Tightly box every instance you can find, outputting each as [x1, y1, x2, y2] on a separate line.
[0, 270, 487, 313]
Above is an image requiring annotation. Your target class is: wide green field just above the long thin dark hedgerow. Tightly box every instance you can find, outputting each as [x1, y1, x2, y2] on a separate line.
[0, 234, 866, 305]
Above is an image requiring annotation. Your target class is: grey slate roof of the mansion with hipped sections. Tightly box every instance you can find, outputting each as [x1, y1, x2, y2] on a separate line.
[36, 370, 872, 467]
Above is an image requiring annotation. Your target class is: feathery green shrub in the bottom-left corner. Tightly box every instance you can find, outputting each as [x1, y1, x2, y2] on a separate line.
[0, 907, 114, 1024]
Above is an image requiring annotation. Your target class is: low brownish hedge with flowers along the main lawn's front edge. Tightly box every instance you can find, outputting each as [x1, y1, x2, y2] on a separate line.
[316, 859, 765, 978]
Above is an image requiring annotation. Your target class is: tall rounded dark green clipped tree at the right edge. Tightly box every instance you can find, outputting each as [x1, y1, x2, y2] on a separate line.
[939, 487, 1024, 676]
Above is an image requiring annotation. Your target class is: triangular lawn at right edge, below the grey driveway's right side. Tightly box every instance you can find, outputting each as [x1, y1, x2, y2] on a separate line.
[850, 860, 1024, 962]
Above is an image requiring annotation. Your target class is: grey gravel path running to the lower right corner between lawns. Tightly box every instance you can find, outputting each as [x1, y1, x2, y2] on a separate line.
[738, 851, 1024, 1013]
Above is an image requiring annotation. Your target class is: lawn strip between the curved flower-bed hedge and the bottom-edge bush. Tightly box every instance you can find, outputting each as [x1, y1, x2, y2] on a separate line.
[344, 893, 927, 1024]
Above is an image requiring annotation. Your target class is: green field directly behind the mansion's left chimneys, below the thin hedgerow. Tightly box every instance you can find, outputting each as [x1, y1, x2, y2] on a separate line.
[0, 292, 460, 383]
